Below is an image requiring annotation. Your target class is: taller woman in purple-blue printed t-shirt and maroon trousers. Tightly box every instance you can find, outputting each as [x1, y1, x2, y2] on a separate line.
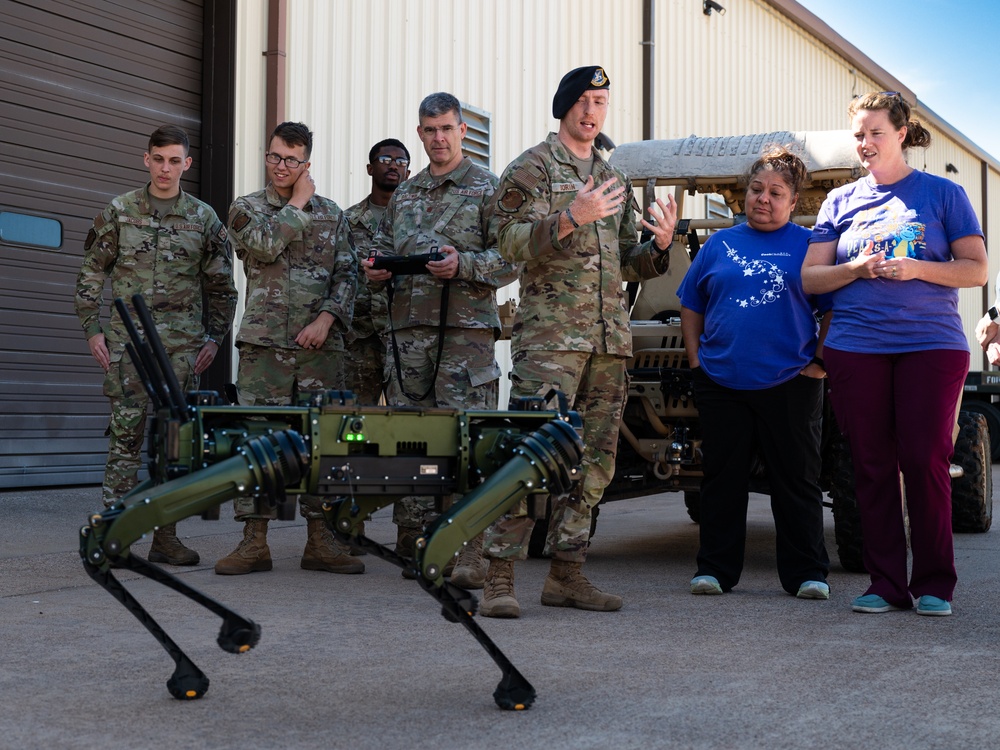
[802, 91, 987, 615]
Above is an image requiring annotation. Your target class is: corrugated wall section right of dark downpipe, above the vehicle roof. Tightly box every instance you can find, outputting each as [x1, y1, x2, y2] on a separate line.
[660, 0, 875, 138]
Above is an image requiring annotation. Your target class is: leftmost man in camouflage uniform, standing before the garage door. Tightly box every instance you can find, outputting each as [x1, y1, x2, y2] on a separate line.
[76, 125, 237, 565]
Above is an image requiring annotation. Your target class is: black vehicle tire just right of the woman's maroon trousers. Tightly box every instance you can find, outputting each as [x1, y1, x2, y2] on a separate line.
[951, 412, 993, 534]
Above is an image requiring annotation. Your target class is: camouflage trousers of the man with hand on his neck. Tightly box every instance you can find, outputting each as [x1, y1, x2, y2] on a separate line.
[233, 343, 344, 521]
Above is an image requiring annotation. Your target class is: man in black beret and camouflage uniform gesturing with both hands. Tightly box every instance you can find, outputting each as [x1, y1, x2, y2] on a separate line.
[480, 66, 676, 617]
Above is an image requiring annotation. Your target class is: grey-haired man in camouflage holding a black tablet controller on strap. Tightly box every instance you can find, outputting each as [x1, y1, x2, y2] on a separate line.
[363, 93, 516, 587]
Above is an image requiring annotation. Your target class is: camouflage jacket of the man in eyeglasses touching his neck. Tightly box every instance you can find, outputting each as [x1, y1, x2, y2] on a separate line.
[229, 185, 358, 350]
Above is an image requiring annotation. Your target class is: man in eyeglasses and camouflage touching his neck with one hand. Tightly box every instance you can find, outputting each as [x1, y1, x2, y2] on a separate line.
[215, 122, 365, 575]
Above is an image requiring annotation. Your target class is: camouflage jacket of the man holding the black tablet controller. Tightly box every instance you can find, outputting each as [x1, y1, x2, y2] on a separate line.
[375, 157, 517, 336]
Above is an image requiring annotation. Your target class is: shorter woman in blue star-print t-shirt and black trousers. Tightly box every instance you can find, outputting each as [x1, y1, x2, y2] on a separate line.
[678, 148, 830, 599]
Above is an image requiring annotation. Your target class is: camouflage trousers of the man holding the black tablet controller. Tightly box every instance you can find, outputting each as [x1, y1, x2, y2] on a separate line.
[385, 326, 500, 529]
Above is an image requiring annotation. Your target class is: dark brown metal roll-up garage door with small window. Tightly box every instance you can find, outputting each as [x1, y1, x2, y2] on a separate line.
[0, 0, 204, 488]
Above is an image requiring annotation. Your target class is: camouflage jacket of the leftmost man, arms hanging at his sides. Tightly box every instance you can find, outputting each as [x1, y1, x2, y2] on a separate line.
[76, 183, 237, 362]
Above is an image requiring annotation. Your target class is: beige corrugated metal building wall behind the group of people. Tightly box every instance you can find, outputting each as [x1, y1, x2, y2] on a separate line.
[237, 0, 1000, 378]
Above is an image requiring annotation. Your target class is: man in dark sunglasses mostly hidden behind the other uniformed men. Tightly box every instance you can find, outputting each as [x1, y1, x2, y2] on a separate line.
[344, 138, 410, 405]
